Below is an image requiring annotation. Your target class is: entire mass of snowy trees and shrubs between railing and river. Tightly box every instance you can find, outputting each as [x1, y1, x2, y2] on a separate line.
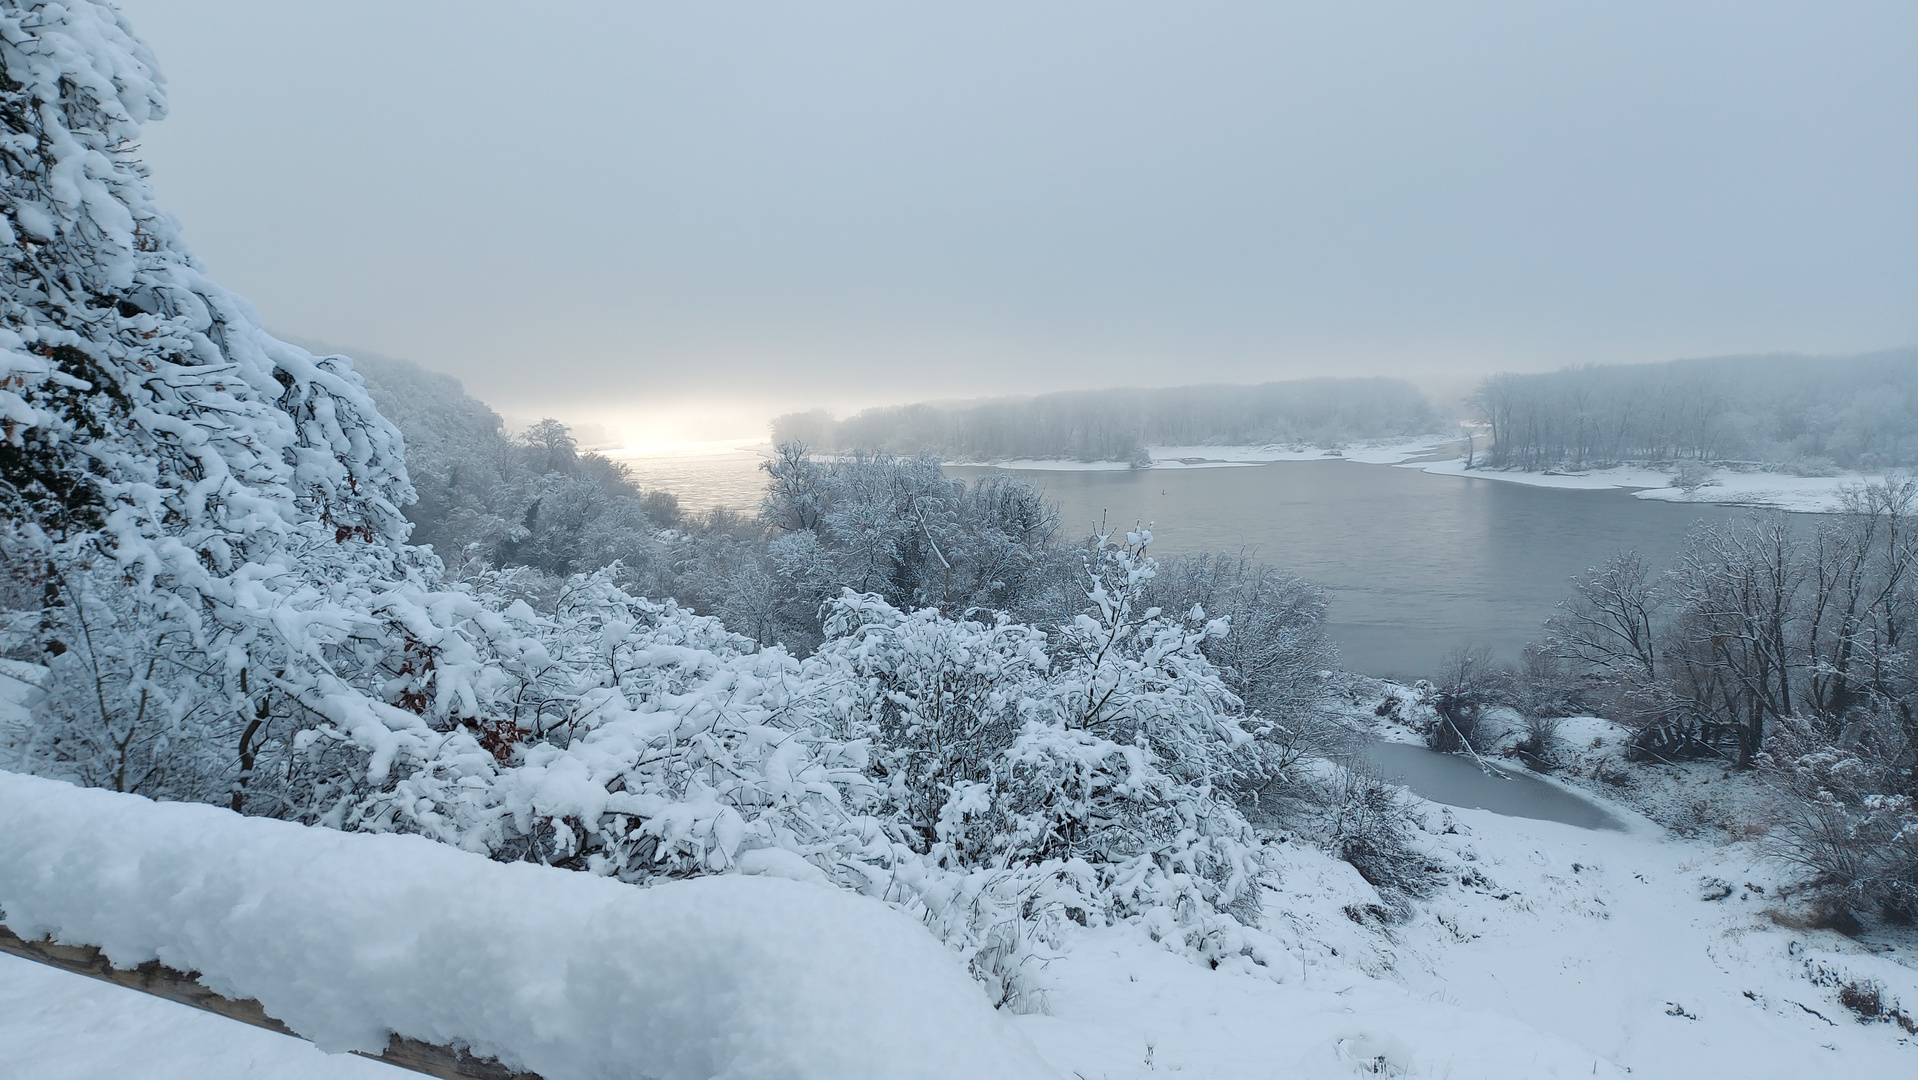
[0, 0, 1426, 1003]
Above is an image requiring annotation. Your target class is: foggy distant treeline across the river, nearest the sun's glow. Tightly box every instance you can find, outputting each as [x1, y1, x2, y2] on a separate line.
[773, 378, 1454, 464]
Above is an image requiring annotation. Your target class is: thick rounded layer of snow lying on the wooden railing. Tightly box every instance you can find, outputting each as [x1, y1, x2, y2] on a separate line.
[0, 771, 1047, 1080]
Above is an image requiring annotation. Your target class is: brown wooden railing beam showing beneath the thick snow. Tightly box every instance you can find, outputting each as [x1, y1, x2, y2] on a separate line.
[0, 925, 541, 1080]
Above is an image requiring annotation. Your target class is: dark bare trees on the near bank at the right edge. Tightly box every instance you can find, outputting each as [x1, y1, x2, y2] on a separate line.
[1534, 478, 1918, 919]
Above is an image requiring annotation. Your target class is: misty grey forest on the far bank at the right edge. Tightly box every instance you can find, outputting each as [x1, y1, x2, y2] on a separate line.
[1471, 349, 1918, 472]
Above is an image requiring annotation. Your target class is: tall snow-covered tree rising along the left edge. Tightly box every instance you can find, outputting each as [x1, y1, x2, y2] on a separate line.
[0, 4, 432, 804]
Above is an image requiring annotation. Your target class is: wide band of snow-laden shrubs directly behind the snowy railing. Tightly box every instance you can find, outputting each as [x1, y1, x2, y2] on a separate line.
[349, 549, 1262, 974]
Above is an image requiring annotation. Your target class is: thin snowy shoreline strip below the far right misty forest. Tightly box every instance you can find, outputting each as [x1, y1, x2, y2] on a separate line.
[1400, 458, 1885, 514]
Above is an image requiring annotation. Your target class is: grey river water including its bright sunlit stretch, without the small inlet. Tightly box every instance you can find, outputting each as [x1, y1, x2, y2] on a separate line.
[618, 443, 1747, 677]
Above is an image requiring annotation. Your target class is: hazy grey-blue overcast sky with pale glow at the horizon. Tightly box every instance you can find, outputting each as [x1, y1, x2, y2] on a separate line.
[112, 0, 1918, 435]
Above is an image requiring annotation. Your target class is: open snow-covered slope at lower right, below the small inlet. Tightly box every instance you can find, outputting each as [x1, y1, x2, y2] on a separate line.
[1018, 790, 1918, 1078]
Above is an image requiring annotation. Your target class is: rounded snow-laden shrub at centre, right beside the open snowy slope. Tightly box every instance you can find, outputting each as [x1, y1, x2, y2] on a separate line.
[782, 533, 1262, 994]
